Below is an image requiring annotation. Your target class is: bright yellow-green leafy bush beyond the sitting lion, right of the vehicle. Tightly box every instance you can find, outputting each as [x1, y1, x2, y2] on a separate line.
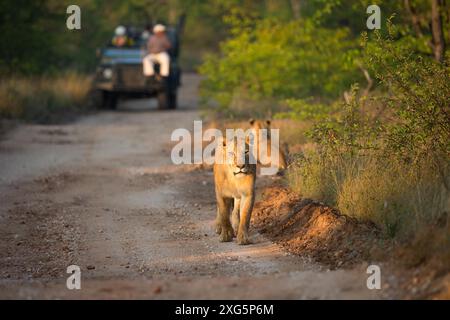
[200, 18, 360, 115]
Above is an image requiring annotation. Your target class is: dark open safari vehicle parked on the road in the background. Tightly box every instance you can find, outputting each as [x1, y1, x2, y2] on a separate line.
[93, 19, 182, 109]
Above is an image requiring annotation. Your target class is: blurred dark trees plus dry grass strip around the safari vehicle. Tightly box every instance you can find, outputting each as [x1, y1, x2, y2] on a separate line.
[0, 0, 229, 122]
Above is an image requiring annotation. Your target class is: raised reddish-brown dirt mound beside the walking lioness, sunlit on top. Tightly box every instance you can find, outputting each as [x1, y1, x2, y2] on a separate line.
[252, 186, 380, 268]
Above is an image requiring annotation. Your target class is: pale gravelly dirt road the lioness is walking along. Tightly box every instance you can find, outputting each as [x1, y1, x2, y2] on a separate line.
[0, 75, 383, 299]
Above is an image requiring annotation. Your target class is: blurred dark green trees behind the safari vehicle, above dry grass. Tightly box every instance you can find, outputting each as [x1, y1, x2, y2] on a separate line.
[0, 0, 232, 76]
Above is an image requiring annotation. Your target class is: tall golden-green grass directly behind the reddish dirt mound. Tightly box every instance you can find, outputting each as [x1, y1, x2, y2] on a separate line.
[287, 146, 450, 238]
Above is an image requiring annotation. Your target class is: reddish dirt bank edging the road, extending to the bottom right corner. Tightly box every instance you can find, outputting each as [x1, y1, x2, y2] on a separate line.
[252, 186, 450, 299]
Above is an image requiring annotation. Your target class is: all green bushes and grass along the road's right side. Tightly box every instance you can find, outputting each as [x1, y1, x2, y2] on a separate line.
[200, 0, 450, 270]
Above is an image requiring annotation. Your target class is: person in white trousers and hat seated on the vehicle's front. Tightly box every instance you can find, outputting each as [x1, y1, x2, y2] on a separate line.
[143, 24, 171, 78]
